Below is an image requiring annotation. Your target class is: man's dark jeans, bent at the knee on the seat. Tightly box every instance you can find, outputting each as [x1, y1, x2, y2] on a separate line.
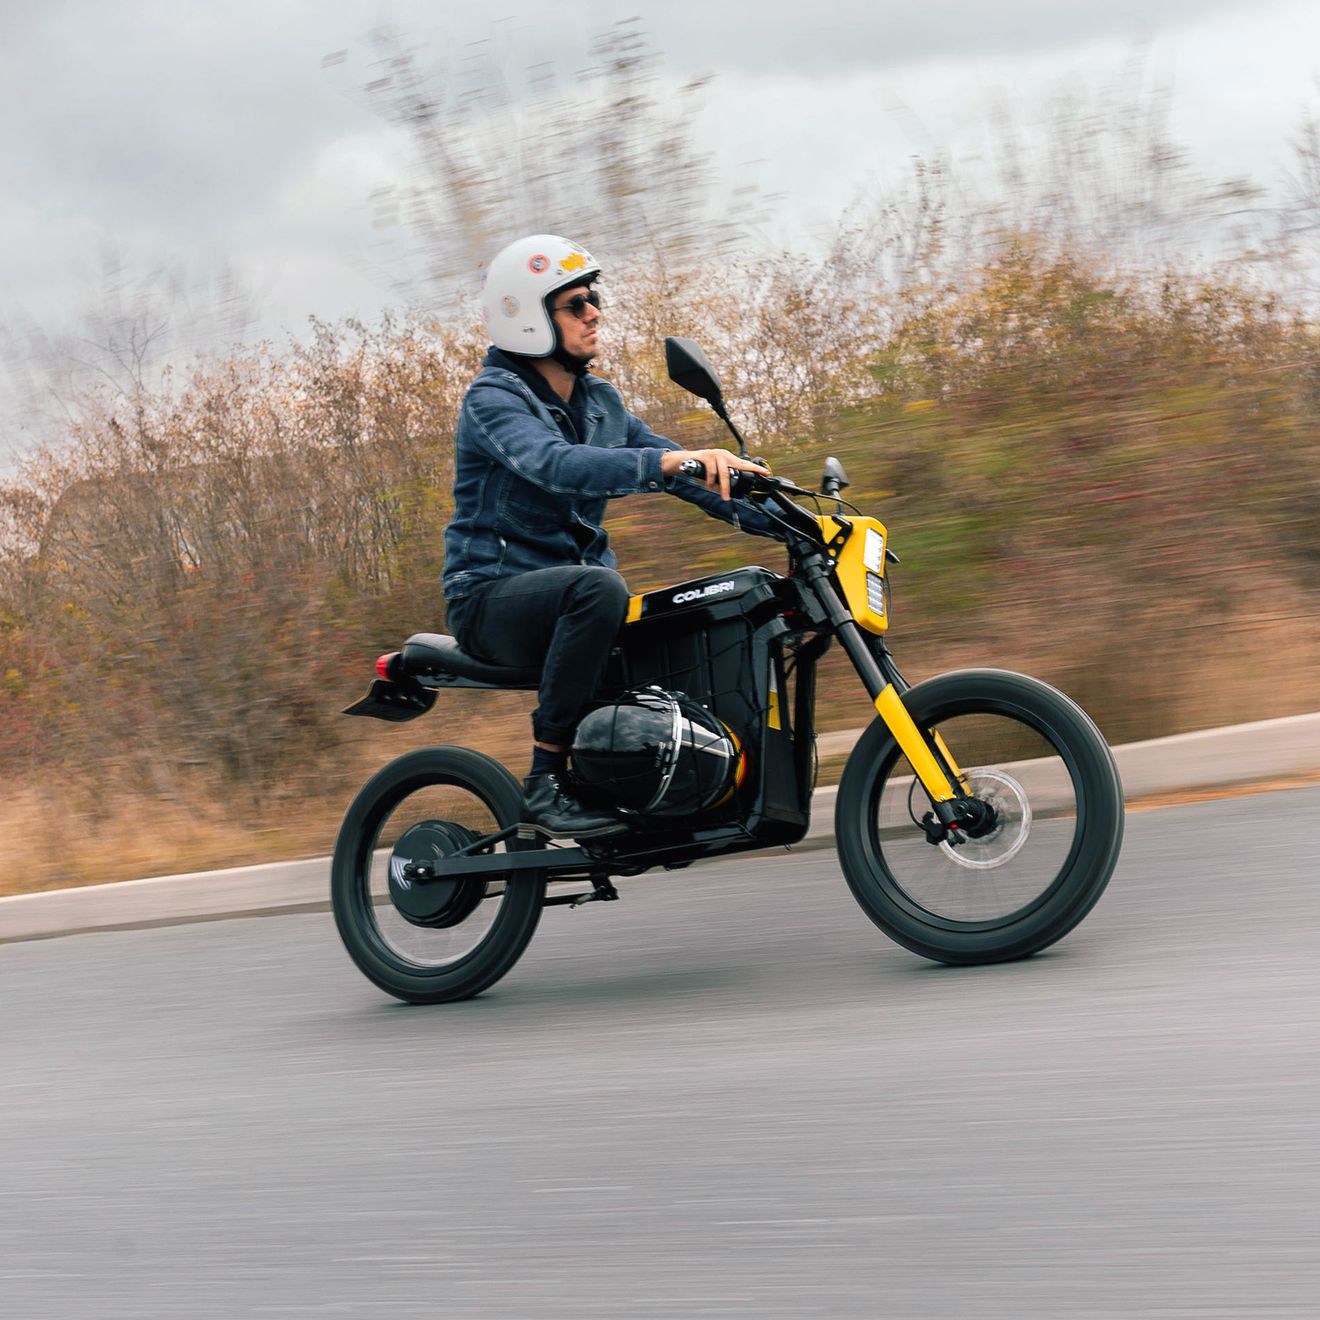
[447, 565, 628, 746]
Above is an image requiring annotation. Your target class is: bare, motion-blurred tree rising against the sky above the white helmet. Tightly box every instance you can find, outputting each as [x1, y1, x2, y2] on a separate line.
[367, 18, 751, 292]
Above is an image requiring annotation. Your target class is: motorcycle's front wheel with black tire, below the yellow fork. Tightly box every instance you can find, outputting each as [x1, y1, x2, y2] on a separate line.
[834, 669, 1123, 964]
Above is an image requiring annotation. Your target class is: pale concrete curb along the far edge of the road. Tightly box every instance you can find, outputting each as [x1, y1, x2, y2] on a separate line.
[0, 713, 1320, 944]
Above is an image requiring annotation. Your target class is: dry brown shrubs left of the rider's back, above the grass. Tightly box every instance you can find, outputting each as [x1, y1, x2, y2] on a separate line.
[0, 322, 475, 808]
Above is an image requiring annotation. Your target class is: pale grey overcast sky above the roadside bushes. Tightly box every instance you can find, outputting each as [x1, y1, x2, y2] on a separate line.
[0, 0, 1320, 469]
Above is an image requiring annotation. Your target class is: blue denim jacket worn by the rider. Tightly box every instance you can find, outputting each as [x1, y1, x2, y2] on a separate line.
[444, 350, 774, 601]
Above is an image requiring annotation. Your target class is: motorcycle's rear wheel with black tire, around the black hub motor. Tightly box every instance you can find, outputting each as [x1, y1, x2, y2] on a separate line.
[330, 747, 545, 1003]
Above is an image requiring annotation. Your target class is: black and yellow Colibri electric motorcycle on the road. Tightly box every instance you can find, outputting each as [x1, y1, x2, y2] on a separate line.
[331, 338, 1123, 1003]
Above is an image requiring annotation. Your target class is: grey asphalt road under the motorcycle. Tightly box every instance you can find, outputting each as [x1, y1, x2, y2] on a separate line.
[0, 788, 1320, 1320]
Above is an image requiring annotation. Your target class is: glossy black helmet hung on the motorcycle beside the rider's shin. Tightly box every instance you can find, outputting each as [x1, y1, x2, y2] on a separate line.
[573, 688, 746, 816]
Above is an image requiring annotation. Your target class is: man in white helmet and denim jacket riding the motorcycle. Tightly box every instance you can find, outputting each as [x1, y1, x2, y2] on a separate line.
[444, 234, 771, 838]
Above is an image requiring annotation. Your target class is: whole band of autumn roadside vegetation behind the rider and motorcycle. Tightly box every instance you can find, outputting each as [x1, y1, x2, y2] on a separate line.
[0, 28, 1320, 892]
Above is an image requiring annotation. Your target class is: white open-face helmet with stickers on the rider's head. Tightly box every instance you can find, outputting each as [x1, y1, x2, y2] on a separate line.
[482, 234, 601, 358]
